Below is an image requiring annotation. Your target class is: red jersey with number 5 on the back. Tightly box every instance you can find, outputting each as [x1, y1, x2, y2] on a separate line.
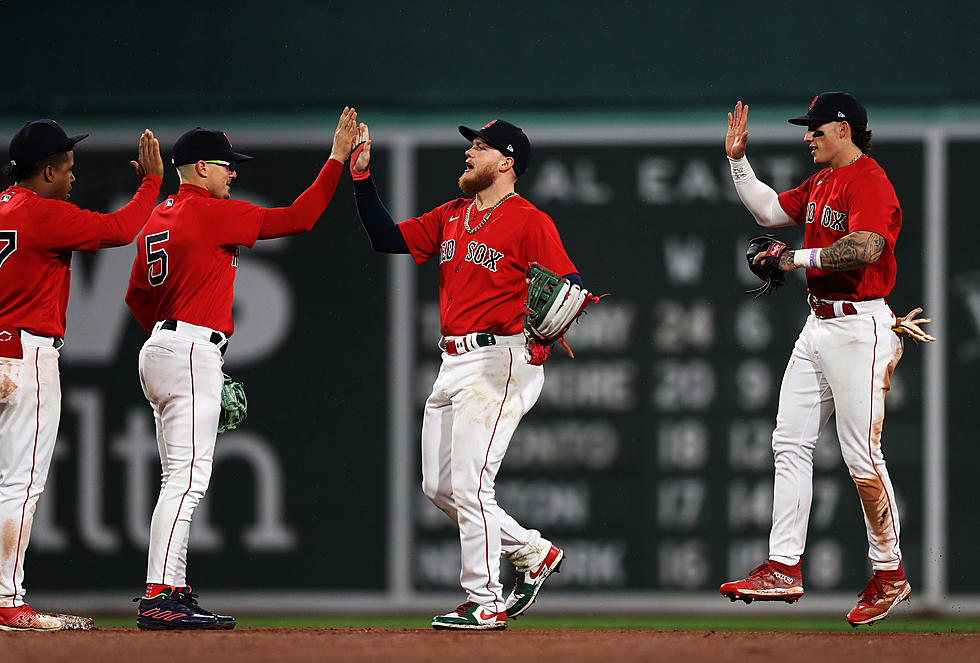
[129, 184, 266, 336]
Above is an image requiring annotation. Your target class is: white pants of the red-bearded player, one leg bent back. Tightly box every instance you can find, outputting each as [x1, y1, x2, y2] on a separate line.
[422, 336, 544, 612]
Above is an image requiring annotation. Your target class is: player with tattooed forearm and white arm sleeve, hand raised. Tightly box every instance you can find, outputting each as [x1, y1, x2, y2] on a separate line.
[721, 92, 931, 626]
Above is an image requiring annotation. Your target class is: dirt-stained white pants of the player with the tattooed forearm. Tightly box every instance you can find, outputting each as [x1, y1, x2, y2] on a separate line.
[769, 299, 903, 570]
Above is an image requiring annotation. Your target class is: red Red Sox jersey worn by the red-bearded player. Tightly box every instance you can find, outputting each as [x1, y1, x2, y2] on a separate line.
[398, 196, 578, 336]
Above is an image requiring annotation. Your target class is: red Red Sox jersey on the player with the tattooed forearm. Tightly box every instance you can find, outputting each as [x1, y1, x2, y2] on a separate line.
[779, 156, 902, 301]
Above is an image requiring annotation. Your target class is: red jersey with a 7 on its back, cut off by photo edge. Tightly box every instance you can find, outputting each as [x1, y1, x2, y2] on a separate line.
[0, 175, 161, 338]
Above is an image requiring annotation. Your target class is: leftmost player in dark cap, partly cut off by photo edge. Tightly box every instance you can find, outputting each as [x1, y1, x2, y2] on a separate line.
[0, 120, 163, 631]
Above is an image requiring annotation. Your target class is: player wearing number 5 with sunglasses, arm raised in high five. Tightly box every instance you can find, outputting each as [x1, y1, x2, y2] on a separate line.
[126, 108, 357, 629]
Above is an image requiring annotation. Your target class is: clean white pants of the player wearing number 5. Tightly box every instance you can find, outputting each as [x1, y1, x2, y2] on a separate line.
[139, 323, 224, 587]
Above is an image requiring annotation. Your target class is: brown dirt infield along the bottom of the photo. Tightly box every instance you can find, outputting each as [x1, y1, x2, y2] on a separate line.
[0, 628, 980, 663]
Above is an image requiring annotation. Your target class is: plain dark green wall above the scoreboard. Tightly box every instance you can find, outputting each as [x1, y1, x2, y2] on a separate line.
[0, 0, 980, 119]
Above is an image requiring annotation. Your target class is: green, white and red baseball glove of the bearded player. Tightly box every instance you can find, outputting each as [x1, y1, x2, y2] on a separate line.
[524, 262, 605, 365]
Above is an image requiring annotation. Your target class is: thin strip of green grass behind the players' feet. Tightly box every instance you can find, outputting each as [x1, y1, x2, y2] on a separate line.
[88, 614, 980, 633]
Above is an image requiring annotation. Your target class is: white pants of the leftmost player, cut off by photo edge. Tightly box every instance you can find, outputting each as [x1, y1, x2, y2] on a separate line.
[0, 332, 61, 608]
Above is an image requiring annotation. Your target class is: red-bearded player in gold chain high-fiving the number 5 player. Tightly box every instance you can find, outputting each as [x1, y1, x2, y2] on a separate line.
[351, 120, 582, 630]
